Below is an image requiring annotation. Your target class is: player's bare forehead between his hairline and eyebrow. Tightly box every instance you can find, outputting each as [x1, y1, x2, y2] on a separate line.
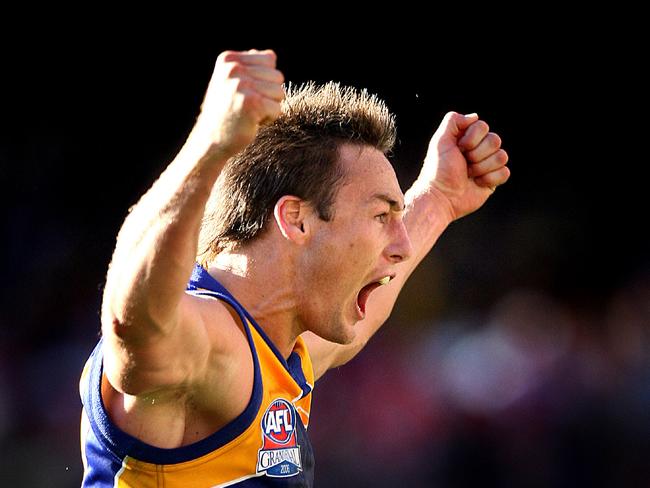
[339, 144, 403, 202]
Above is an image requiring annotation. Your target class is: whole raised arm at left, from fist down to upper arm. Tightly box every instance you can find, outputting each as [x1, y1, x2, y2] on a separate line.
[102, 51, 284, 394]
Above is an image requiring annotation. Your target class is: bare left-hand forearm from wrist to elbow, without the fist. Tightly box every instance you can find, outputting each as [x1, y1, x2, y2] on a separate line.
[102, 131, 227, 339]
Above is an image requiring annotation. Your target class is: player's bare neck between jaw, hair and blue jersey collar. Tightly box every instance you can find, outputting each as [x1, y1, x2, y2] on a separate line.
[208, 243, 302, 359]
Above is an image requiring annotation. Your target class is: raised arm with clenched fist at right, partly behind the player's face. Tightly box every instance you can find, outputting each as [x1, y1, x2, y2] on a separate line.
[304, 112, 510, 377]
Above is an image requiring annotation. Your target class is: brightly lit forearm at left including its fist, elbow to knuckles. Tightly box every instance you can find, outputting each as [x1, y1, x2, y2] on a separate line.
[102, 50, 284, 345]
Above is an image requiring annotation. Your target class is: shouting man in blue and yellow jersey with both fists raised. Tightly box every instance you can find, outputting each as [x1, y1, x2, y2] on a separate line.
[81, 47, 509, 487]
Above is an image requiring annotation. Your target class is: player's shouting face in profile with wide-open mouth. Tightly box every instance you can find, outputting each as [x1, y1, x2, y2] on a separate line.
[300, 144, 411, 344]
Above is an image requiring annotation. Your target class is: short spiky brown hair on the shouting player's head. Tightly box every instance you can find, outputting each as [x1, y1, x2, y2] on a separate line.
[198, 82, 396, 265]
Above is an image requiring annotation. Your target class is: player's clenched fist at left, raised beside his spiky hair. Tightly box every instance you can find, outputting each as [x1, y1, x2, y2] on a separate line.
[196, 50, 284, 156]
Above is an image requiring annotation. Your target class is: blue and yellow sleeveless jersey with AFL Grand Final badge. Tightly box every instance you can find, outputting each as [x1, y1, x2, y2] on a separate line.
[80, 265, 314, 488]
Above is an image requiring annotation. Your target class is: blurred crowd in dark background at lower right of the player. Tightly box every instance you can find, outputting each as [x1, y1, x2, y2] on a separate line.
[311, 276, 650, 488]
